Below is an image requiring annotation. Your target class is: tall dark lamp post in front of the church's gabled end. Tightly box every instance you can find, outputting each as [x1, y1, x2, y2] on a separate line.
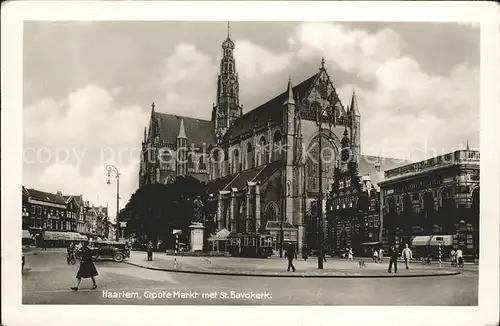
[313, 90, 335, 269]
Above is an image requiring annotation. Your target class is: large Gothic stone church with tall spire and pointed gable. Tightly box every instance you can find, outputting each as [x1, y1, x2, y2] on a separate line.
[139, 26, 404, 250]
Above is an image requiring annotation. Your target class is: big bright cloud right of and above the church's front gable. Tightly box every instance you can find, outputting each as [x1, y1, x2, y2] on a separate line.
[293, 23, 479, 160]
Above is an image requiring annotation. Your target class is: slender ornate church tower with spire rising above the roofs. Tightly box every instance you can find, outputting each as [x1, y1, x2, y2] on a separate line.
[212, 23, 243, 140]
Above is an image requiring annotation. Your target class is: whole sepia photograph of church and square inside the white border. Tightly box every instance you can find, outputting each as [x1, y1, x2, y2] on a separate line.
[11, 8, 492, 306]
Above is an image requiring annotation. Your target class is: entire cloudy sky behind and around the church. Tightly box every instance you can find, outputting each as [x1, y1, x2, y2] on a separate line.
[23, 22, 480, 220]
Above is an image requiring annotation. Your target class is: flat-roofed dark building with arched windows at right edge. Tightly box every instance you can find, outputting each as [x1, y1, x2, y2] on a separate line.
[380, 146, 480, 255]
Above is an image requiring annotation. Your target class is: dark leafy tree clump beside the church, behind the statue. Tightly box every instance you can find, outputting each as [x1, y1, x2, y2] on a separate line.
[120, 176, 213, 248]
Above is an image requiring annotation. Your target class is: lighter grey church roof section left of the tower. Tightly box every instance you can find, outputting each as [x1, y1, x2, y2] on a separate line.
[154, 112, 216, 146]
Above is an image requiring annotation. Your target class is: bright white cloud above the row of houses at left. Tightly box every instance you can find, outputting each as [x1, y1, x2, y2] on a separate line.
[23, 84, 148, 214]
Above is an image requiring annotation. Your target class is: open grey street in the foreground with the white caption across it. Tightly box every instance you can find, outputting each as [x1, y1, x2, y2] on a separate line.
[22, 251, 478, 306]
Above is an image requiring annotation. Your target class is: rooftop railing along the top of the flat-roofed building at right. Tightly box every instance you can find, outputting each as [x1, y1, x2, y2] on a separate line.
[384, 150, 480, 179]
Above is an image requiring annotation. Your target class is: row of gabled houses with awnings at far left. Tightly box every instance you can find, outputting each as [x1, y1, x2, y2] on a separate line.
[22, 186, 115, 239]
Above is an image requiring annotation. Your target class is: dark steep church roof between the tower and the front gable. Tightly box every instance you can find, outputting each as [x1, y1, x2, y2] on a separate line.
[224, 74, 318, 141]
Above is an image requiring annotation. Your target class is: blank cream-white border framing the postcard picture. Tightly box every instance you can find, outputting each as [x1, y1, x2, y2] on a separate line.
[1, 1, 500, 326]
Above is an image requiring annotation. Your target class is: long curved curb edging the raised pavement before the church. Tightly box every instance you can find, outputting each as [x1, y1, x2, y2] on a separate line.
[124, 261, 461, 278]
